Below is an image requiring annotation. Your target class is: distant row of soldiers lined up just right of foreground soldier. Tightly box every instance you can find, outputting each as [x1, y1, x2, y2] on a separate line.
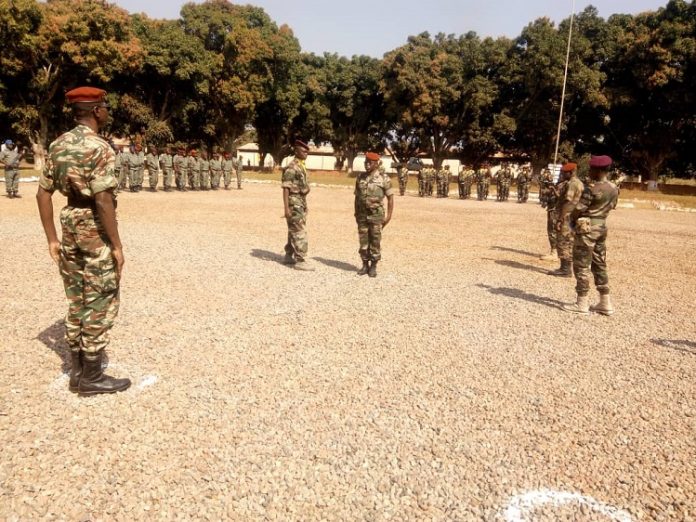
[114, 144, 242, 192]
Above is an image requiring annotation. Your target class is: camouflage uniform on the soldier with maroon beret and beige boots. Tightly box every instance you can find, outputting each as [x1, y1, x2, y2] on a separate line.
[572, 181, 619, 296]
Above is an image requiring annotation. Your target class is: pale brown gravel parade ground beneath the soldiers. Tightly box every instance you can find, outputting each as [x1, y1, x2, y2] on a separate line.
[0, 183, 696, 522]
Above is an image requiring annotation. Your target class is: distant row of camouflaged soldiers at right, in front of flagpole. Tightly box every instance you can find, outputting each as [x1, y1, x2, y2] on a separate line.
[397, 163, 532, 203]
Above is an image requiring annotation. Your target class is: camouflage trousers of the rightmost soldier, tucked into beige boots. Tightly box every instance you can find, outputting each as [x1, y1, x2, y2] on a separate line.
[573, 224, 609, 295]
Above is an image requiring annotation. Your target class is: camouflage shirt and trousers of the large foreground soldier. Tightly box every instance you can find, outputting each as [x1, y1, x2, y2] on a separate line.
[39, 125, 119, 353]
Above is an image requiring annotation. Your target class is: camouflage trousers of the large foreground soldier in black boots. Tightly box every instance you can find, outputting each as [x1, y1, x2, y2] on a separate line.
[60, 207, 120, 353]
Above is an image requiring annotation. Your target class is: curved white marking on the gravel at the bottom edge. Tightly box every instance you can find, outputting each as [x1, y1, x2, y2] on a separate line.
[503, 489, 633, 522]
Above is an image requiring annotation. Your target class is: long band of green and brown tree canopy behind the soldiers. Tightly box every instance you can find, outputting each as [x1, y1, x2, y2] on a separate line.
[0, 0, 696, 179]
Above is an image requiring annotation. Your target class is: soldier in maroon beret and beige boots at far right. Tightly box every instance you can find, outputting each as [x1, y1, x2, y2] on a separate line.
[563, 156, 619, 315]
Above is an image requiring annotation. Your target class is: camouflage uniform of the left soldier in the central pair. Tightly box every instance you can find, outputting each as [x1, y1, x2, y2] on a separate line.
[281, 154, 309, 263]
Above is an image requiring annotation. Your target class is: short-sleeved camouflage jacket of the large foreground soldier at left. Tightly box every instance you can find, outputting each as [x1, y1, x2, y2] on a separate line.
[39, 125, 118, 199]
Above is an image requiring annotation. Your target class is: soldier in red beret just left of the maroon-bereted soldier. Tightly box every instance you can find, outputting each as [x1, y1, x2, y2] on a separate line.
[549, 163, 585, 277]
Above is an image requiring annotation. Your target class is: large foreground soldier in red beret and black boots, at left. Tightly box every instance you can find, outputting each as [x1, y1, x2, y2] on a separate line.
[36, 87, 131, 396]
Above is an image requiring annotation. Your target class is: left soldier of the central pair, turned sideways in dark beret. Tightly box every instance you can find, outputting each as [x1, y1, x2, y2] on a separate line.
[281, 140, 314, 271]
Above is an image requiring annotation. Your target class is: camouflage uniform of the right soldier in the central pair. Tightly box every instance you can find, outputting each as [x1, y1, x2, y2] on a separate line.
[354, 165, 393, 262]
